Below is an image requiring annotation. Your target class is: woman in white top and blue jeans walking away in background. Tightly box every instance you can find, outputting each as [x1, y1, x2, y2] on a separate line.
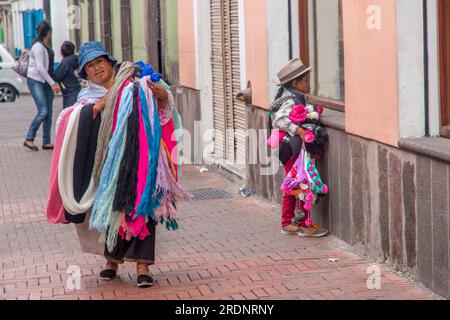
[24, 21, 60, 151]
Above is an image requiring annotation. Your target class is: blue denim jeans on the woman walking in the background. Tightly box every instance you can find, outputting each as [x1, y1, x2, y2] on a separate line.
[26, 78, 55, 145]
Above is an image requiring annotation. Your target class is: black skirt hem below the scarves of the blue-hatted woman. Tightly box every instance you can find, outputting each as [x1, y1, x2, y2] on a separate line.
[105, 221, 157, 265]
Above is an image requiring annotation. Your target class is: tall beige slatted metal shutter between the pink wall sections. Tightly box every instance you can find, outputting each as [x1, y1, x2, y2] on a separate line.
[210, 0, 247, 168]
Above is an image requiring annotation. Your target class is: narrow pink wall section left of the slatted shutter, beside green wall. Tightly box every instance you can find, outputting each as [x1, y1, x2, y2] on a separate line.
[178, 0, 198, 89]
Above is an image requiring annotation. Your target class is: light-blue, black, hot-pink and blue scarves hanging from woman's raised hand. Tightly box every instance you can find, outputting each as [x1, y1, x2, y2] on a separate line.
[90, 77, 189, 249]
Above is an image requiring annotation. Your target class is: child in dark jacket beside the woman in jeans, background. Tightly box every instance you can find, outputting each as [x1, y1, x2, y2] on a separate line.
[54, 41, 81, 109]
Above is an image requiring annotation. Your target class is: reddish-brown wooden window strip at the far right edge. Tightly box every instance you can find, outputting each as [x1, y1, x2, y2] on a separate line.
[439, 0, 450, 138]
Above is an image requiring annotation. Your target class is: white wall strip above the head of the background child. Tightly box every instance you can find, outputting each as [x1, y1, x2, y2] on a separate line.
[50, 0, 70, 61]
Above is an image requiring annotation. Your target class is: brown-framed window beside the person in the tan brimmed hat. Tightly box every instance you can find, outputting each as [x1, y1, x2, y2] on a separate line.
[299, 0, 345, 111]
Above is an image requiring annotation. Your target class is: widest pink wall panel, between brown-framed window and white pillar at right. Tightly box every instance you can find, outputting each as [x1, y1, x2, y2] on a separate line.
[343, 0, 400, 146]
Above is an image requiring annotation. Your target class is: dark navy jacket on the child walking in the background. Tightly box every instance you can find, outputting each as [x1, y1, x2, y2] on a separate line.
[53, 55, 81, 94]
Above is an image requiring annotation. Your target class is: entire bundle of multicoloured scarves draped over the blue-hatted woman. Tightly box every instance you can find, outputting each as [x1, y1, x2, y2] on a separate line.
[47, 63, 186, 252]
